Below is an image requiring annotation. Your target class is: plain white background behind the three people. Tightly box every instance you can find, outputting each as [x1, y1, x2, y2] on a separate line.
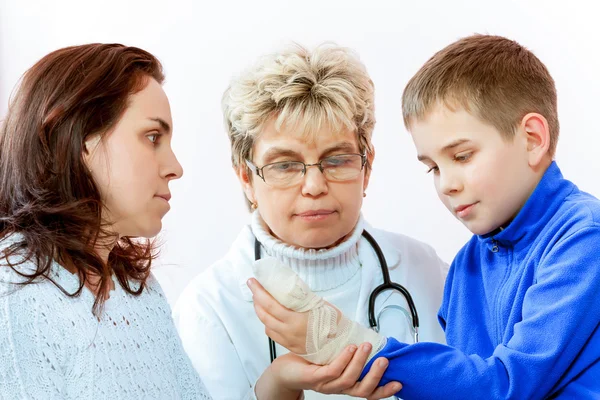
[0, 0, 600, 303]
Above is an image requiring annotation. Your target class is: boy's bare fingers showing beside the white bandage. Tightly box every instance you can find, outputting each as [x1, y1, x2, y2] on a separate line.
[248, 278, 314, 354]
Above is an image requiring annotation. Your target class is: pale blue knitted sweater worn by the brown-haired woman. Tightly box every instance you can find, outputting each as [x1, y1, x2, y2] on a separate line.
[0, 234, 210, 400]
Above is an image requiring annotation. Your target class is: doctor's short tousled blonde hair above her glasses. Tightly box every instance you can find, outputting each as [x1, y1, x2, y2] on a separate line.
[222, 43, 375, 167]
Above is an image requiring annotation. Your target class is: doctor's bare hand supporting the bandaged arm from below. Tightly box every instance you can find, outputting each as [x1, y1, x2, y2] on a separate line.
[255, 343, 402, 400]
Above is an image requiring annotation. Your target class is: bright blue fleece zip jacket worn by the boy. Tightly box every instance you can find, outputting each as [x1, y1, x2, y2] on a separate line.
[361, 163, 600, 399]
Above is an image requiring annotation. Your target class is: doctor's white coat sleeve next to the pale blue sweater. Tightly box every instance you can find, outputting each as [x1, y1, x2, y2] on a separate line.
[173, 288, 256, 400]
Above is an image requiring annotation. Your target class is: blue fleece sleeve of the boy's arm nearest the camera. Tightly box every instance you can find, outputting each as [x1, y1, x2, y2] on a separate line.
[361, 227, 600, 400]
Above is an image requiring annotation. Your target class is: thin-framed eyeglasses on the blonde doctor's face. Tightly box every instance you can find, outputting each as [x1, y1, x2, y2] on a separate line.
[246, 154, 367, 188]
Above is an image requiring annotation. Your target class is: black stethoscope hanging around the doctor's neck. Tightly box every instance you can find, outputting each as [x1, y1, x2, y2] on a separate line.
[254, 230, 419, 362]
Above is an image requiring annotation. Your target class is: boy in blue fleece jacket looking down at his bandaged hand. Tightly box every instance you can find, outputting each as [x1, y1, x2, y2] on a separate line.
[251, 35, 600, 399]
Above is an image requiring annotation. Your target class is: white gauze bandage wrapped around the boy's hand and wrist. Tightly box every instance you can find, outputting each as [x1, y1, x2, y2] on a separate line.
[253, 257, 386, 365]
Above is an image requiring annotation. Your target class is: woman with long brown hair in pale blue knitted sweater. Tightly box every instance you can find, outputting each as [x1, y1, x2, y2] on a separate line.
[0, 44, 210, 399]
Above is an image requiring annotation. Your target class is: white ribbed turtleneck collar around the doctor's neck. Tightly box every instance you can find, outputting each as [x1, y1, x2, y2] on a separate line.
[251, 211, 364, 292]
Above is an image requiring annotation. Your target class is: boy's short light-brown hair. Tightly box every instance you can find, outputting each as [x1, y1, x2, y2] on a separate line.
[402, 35, 559, 155]
